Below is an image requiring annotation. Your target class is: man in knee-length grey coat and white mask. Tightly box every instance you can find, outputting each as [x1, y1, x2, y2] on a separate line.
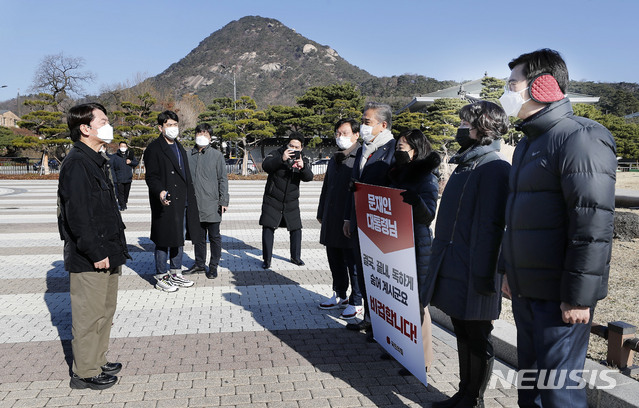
[184, 123, 229, 279]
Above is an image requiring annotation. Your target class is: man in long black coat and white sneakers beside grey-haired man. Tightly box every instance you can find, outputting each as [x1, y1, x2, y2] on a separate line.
[317, 119, 361, 309]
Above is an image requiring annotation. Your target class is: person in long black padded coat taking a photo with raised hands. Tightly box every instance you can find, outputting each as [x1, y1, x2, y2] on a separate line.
[260, 132, 313, 269]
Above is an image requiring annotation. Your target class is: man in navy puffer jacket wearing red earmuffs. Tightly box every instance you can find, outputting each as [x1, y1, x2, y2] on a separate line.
[500, 49, 617, 407]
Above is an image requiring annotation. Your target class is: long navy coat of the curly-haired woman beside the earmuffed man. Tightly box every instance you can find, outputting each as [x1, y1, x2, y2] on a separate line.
[427, 140, 510, 320]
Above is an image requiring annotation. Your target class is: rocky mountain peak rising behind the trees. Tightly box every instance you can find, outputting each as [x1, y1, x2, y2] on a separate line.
[147, 16, 453, 108]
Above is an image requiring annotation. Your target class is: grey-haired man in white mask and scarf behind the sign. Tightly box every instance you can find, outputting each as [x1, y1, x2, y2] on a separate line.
[341, 102, 395, 330]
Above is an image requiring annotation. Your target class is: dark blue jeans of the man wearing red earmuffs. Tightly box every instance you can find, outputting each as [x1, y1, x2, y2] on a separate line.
[513, 296, 594, 408]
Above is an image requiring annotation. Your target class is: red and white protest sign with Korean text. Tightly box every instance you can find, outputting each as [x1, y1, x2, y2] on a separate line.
[355, 183, 427, 385]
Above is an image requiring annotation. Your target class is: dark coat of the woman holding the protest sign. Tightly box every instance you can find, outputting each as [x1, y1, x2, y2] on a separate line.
[389, 152, 441, 305]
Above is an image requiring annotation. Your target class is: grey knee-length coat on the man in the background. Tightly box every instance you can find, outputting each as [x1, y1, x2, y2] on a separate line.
[189, 146, 229, 222]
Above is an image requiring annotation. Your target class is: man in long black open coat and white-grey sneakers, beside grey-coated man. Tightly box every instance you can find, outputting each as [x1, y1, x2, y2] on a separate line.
[144, 111, 200, 292]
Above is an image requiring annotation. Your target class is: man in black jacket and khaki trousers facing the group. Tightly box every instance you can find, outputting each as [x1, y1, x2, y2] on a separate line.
[58, 103, 130, 390]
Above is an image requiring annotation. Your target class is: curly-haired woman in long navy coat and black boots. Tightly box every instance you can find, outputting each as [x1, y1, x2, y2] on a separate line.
[428, 101, 510, 407]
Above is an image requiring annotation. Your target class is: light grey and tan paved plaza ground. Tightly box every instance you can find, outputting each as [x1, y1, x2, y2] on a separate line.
[0, 180, 516, 408]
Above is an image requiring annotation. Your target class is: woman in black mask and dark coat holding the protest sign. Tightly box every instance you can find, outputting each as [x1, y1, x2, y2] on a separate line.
[388, 129, 441, 374]
